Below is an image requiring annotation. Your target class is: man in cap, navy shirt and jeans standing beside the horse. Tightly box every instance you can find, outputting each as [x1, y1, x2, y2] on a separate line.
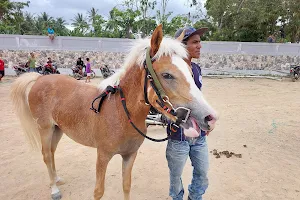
[166, 27, 208, 200]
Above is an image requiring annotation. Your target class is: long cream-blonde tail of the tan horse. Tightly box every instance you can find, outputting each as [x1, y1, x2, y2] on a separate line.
[10, 73, 41, 150]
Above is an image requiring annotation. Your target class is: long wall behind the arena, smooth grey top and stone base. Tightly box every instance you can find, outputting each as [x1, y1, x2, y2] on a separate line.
[0, 34, 300, 73]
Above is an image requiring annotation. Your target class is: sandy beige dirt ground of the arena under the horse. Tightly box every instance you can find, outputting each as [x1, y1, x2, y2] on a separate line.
[0, 78, 300, 200]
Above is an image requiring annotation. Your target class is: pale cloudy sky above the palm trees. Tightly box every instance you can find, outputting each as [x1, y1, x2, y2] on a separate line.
[13, 0, 206, 26]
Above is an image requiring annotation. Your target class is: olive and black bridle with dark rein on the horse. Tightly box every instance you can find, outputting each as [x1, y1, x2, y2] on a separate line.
[90, 47, 191, 142]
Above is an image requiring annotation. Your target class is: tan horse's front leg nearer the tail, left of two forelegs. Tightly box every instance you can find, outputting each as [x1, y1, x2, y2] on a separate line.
[94, 148, 112, 200]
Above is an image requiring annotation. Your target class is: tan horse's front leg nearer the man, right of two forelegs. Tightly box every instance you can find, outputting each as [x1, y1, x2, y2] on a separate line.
[122, 152, 137, 200]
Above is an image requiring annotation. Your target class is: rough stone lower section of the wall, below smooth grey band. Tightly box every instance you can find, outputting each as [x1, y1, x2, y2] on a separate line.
[0, 50, 300, 71]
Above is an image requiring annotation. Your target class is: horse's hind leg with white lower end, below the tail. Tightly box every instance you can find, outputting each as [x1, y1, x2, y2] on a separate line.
[39, 126, 61, 200]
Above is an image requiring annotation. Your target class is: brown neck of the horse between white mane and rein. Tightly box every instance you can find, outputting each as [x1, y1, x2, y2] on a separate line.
[120, 66, 150, 124]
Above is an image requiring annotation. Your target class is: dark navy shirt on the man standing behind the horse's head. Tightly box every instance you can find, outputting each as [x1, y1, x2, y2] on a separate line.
[167, 62, 206, 140]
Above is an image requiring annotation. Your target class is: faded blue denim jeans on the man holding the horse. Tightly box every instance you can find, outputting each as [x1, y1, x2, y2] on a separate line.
[166, 136, 208, 200]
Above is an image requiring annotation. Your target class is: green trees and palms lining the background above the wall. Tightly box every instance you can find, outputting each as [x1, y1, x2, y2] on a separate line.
[0, 0, 300, 42]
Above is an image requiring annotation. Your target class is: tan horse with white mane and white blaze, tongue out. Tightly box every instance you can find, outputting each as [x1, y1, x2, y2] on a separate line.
[11, 25, 216, 200]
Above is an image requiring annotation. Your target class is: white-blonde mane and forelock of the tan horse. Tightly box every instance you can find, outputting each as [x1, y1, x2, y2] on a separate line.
[99, 37, 188, 90]
